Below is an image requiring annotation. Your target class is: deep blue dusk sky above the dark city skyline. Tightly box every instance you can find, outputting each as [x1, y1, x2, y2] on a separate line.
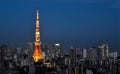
[0, 0, 120, 50]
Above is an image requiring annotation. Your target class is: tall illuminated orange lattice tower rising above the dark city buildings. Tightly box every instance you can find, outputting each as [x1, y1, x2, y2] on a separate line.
[33, 10, 44, 62]
